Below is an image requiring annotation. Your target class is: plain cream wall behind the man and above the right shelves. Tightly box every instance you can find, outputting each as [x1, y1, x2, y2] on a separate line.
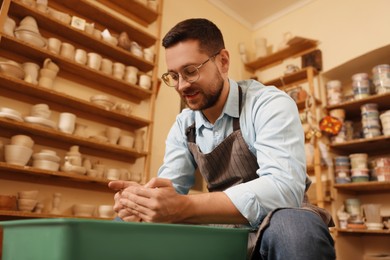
[151, 0, 390, 176]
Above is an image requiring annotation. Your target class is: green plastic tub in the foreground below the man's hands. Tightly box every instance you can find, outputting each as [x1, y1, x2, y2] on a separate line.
[0, 218, 249, 260]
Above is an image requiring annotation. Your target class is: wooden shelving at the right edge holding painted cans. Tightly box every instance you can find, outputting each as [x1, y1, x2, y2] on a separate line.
[322, 45, 390, 260]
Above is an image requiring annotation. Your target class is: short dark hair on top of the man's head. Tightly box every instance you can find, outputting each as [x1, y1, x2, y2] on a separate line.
[162, 18, 225, 56]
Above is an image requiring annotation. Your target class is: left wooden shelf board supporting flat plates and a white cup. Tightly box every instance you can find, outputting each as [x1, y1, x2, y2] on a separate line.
[0, 118, 147, 162]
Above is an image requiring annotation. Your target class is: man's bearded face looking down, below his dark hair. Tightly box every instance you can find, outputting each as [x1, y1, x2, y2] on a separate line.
[165, 40, 224, 110]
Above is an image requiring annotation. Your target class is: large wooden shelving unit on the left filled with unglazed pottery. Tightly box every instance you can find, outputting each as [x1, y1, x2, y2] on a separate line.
[0, 0, 163, 220]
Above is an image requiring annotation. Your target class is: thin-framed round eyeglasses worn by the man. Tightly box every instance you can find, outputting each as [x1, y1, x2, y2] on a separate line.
[161, 51, 221, 87]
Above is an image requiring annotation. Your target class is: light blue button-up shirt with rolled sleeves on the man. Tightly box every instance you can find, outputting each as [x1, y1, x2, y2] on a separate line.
[158, 80, 306, 228]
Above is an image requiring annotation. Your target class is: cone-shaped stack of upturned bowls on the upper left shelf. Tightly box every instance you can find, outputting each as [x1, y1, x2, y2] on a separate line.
[15, 16, 46, 48]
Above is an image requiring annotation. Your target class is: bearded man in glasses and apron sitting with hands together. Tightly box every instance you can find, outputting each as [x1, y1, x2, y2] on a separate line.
[109, 19, 335, 260]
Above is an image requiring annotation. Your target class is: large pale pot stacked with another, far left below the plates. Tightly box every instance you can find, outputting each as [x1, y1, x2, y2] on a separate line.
[4, 135, 34, 166]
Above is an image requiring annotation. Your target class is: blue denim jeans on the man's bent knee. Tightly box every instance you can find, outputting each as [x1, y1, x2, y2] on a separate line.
[254, 208, 336, 260]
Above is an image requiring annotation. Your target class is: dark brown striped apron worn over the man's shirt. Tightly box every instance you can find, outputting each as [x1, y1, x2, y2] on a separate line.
[186, 87, 333, 259]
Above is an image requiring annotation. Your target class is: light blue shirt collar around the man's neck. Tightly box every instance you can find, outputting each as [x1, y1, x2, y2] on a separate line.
[195, 79, 239, 130]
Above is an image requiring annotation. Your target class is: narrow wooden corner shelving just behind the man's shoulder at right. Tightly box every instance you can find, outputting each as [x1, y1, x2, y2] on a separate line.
[245, 37, 330, 208]
